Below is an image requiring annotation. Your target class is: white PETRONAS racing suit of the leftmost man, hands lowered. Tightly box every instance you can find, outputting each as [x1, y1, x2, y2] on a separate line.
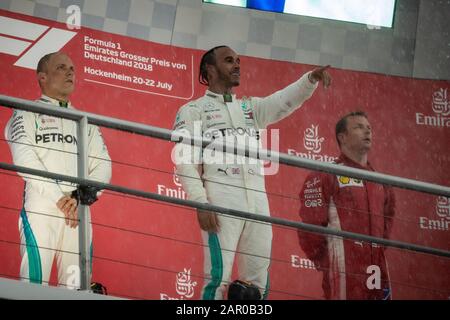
[5, 96, 111, 289]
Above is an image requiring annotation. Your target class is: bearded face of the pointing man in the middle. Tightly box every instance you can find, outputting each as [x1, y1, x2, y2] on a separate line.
[210, 47, 241, 88]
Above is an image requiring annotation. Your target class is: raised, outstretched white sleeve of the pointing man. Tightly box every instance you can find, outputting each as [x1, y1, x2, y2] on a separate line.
[252, 72, 318, 128]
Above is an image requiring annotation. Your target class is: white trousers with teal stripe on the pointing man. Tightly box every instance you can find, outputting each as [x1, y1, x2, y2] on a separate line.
[202, 183, 272, 299]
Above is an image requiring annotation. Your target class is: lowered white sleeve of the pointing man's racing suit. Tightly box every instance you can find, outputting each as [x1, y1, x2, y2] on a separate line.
[172, 104, 208, 203]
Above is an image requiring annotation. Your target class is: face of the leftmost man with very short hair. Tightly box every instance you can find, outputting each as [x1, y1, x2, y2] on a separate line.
[39, 54, 75, 99]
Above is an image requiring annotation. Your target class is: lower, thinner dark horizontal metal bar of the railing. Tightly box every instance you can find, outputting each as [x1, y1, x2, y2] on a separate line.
[0, 162, 450, 258]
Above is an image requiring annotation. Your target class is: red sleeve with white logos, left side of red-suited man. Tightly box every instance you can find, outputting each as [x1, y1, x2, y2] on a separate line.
[298, 172, 330, 267]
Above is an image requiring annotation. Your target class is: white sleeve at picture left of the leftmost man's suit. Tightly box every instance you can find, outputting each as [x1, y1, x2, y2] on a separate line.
[5, 110, 64, 203]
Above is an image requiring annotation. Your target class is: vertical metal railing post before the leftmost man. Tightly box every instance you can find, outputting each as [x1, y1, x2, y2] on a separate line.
[77, 116, 91, 290]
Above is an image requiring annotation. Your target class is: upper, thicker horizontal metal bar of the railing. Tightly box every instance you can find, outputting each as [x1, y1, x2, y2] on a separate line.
[0, 95, 450, 197]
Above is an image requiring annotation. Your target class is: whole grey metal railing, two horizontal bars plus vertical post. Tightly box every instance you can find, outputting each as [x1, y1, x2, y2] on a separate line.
[0, 95, 450, 290]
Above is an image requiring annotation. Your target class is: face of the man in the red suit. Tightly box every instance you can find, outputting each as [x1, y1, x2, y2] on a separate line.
[340, 116, 372, 152]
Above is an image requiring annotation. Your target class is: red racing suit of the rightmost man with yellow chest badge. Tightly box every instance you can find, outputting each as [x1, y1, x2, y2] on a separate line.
[298, 154, 395, 299]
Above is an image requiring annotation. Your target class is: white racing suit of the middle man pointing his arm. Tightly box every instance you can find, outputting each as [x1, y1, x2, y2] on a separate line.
[172, 74, 317, 299]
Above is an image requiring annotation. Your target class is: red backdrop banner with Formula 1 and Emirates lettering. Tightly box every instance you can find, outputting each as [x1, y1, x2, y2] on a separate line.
[0, 10, 450, 300]
